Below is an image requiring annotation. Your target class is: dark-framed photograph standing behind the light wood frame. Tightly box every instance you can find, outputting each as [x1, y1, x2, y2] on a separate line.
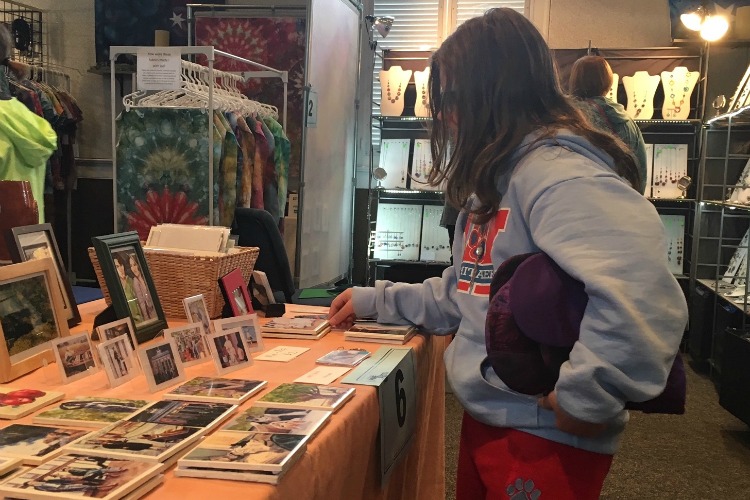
[8, 224, 81, 326]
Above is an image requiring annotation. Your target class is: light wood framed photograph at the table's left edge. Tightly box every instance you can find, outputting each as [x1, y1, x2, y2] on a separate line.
[0, 259, 69, 382]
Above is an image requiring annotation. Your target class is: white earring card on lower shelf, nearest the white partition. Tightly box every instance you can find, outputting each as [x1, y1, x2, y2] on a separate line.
[373, 203, 423, 260]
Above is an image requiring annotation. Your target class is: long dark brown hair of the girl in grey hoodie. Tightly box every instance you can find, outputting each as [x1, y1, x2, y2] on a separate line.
[429, 8, 640, 223]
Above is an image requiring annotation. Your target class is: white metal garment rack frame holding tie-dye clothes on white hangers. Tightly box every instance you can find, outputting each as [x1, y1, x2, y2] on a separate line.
[109, 46, 289, 231]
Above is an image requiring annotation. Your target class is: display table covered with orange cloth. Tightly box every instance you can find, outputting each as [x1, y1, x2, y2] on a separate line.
[8, 300, 446, 500]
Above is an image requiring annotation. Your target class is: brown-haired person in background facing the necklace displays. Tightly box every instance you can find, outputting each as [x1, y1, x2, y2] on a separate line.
[568, 56, 647, 193]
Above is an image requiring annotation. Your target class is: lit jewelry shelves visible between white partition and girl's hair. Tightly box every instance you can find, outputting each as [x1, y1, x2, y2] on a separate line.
[365, 50, 450, 284]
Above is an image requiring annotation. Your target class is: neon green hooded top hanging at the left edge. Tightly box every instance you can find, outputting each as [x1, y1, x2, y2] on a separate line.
[0, 98, 57, 219]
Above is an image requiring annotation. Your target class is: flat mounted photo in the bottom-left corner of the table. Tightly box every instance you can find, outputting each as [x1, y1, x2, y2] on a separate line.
[0, 454, 162, 500]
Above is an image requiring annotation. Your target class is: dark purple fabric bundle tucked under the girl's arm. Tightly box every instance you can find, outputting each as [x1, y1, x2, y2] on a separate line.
[485, 252, 686, 414]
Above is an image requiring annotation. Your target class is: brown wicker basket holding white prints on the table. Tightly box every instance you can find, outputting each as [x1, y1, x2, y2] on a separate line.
[89, 247, 259, 318]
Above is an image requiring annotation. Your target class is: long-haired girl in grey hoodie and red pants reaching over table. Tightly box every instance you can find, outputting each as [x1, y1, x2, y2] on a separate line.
[329, 8, 687, 500]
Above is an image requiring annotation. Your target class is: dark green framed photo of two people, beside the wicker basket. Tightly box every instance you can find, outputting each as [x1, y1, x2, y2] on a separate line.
[91, 231, 167, 343]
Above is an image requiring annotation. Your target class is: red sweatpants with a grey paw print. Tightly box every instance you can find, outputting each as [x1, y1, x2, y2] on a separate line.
[456, 413, 612, 500]
